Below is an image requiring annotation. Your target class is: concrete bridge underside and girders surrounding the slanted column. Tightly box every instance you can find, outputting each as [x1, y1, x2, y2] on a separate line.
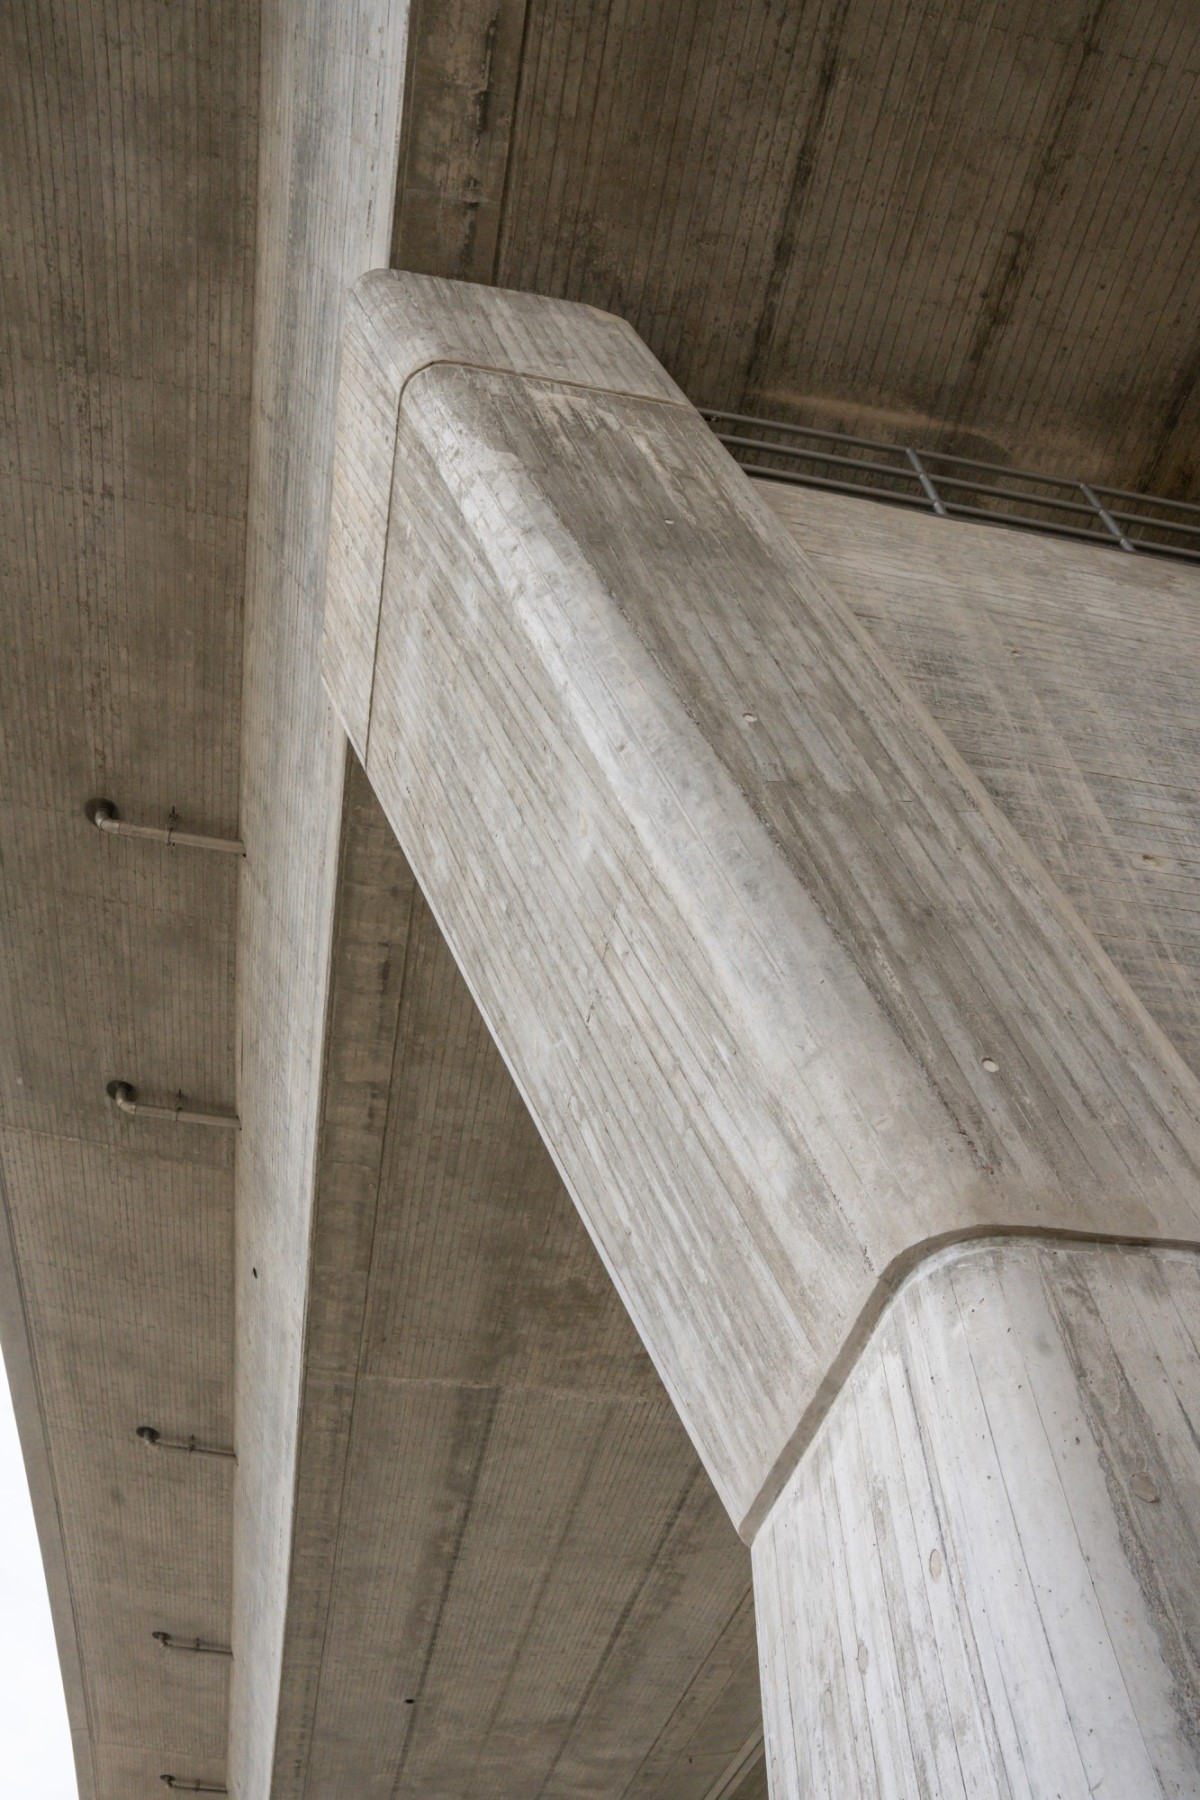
[0, 0, 1200, 1800]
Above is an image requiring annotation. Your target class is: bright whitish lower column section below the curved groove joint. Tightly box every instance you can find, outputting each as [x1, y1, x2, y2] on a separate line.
[754, 1240, 1200, 1800]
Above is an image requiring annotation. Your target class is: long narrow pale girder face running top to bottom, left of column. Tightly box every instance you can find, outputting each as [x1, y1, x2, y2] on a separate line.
[228, 0, 407, 1800]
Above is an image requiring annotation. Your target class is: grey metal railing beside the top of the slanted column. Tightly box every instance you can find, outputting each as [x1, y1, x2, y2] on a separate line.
[700, 407, 1200, 562]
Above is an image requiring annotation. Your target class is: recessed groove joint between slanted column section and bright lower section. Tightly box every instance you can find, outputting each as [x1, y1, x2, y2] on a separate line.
[738, 1224, 1200, 1544]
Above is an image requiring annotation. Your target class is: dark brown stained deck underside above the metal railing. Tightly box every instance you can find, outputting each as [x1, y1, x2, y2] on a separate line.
[392, 0, 1200, 499]
